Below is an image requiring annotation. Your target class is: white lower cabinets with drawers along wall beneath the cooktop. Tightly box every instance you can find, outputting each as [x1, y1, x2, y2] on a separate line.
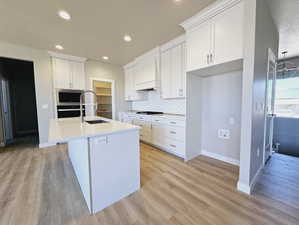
[120, 113, 186, 158]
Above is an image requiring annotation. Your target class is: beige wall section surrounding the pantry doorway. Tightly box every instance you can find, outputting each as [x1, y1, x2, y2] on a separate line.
[85, 60, 129, 118]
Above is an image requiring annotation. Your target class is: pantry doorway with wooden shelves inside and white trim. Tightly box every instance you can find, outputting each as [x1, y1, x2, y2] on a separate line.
[91, 78, 115, 119]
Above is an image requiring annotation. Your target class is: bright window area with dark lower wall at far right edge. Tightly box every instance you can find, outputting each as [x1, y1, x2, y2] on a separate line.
[273, 55, 299, 157]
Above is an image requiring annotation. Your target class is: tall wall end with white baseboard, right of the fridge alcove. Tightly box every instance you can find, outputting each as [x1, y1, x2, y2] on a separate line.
[238, 0, 279, 193]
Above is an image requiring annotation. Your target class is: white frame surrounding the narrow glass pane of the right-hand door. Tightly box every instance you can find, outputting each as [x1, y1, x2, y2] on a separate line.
[263, 48, 277, 165]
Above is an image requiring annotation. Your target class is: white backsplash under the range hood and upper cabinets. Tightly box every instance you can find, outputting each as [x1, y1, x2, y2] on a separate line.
[132, 91, 186, 115]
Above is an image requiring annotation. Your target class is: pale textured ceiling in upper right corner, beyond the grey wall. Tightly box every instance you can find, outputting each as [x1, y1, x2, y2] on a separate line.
[268, 0, 299, 57]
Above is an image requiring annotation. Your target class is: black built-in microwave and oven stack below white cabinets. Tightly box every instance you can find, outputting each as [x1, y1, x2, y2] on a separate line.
[56, 89, 85, 118]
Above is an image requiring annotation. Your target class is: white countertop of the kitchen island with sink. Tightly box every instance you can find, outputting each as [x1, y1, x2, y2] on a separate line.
[48, 117, 140, 143]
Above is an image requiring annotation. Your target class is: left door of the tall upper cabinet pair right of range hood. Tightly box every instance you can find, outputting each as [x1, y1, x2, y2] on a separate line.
[161, 49, 172, 98]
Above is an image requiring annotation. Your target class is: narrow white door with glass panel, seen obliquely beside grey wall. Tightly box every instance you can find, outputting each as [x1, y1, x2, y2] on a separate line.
[263, 49, 276, 164]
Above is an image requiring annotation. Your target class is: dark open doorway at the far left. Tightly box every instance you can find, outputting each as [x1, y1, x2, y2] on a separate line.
[0, 58, 39, 146]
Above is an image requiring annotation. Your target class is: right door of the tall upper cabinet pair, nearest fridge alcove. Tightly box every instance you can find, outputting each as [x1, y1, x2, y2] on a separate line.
[171, 45, 184, 98]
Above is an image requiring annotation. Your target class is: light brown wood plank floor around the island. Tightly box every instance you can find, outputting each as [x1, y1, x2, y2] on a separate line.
[0, 144, 299, 225]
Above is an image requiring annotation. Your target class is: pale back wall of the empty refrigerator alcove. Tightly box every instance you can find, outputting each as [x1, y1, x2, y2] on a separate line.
[201, 71, 242, 164]
